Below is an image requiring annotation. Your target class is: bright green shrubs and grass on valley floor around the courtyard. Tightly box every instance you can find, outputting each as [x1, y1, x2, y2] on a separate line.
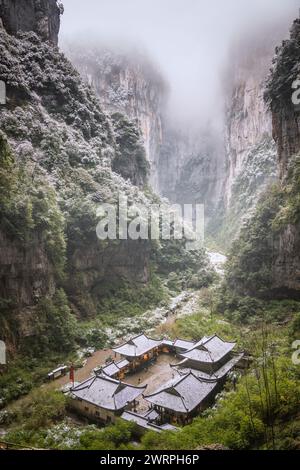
[2, 290, 300, 450]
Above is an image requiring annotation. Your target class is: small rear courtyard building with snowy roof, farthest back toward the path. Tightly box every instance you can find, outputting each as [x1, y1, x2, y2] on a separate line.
[113, 334, 162, 370]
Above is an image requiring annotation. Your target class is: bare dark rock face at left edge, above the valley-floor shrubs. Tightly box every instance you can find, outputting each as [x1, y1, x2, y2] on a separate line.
[0, 231, 56, 351]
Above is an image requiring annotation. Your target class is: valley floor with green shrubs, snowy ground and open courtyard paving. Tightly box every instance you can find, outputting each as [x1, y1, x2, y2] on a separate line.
[0, 252, 300, 450]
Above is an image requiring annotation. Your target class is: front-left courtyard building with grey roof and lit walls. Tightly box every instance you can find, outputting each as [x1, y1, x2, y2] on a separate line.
[70, 375, 146, 424]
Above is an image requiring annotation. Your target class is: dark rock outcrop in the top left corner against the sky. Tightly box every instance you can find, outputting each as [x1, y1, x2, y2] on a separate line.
[0, 0, 63, 45]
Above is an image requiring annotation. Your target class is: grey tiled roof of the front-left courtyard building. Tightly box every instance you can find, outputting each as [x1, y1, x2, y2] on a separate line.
[71, 375, 146, 411]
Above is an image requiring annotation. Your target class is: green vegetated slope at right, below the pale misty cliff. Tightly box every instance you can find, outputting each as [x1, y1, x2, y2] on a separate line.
[224, 156, 300, 297]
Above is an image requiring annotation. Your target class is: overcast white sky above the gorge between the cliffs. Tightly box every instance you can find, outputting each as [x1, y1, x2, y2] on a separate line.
[61, 0, 300, 124]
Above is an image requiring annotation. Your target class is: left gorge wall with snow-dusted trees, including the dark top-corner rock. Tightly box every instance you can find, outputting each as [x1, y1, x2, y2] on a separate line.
[0, 0, 155, 351]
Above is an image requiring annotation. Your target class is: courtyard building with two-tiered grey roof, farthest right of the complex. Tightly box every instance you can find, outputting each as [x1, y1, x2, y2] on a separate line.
[172, 335, 244, 381]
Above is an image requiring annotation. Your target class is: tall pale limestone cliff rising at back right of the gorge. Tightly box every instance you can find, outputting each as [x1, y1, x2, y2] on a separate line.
[216, 30, 284, 248]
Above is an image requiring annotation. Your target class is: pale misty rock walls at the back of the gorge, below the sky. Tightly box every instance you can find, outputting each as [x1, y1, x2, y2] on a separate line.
[65, 20, 287, 242]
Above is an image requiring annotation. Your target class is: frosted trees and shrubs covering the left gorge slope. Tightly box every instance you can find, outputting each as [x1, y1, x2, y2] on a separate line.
[0, 29, 211, 360]
